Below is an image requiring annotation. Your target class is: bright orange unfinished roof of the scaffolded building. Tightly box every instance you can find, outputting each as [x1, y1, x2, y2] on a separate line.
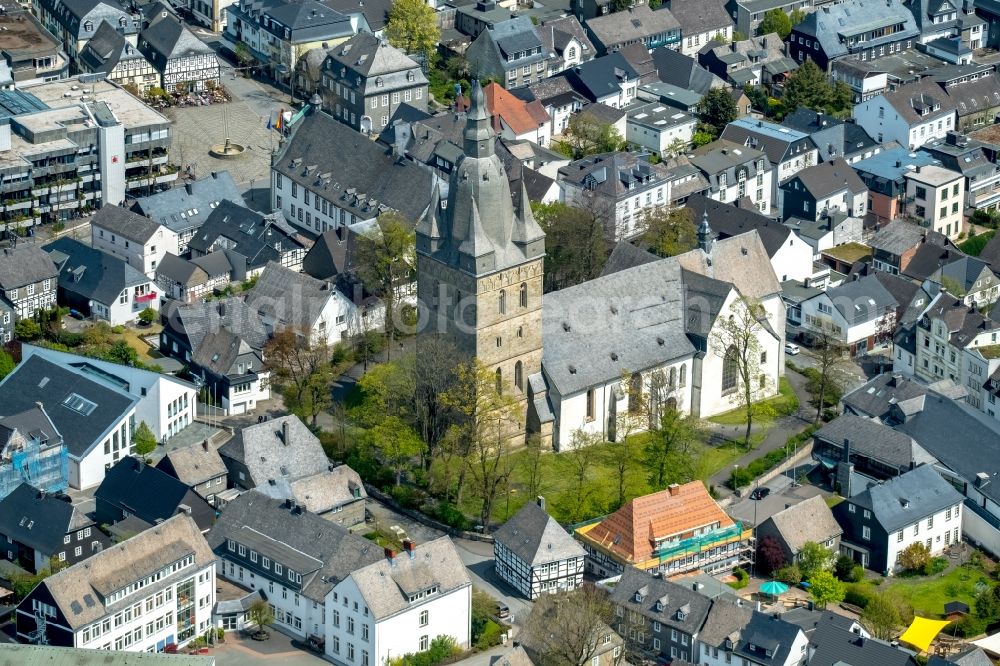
[577, 481, 734, 564]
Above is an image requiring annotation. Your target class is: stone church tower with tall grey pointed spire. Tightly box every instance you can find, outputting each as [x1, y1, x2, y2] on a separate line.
[416, 81, 545, 438]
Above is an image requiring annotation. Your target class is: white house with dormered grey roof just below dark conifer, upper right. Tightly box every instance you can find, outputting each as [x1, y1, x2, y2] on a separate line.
[691, 139, 776, 213]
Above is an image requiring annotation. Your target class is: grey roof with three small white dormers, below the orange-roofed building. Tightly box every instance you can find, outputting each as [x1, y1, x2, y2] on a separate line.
[611, 567, 712, 636]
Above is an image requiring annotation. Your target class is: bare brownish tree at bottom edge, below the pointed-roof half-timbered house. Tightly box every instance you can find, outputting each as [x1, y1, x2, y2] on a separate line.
[519, 583, 614, 666]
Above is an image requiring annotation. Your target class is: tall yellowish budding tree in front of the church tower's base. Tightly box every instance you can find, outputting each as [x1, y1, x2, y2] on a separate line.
[443, 359, 521, 531]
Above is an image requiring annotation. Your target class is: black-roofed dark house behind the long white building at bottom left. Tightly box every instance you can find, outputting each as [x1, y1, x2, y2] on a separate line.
[94, 456, 216, 532]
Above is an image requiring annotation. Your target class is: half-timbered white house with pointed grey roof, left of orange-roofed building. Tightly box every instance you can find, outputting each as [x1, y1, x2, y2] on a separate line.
[493, 497, 586, 599]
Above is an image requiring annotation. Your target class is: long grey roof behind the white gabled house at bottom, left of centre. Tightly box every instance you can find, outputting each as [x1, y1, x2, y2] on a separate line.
[208, 491, 384, 603]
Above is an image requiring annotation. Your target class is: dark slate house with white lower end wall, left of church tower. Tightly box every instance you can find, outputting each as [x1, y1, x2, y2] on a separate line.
[160, 298, 271, 414]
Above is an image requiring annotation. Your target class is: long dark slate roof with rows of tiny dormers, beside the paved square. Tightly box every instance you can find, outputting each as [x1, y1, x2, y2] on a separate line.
[274, 113, 433, 221]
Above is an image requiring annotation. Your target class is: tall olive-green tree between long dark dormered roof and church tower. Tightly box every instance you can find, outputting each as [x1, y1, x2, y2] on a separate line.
[354, 211, 416, 358]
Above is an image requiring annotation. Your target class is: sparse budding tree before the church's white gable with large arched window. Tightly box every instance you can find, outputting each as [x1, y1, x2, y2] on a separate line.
[712, 296, 774, 449]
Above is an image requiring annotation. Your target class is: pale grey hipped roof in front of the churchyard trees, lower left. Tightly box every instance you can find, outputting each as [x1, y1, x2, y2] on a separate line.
[219, 416, 329, 486]
